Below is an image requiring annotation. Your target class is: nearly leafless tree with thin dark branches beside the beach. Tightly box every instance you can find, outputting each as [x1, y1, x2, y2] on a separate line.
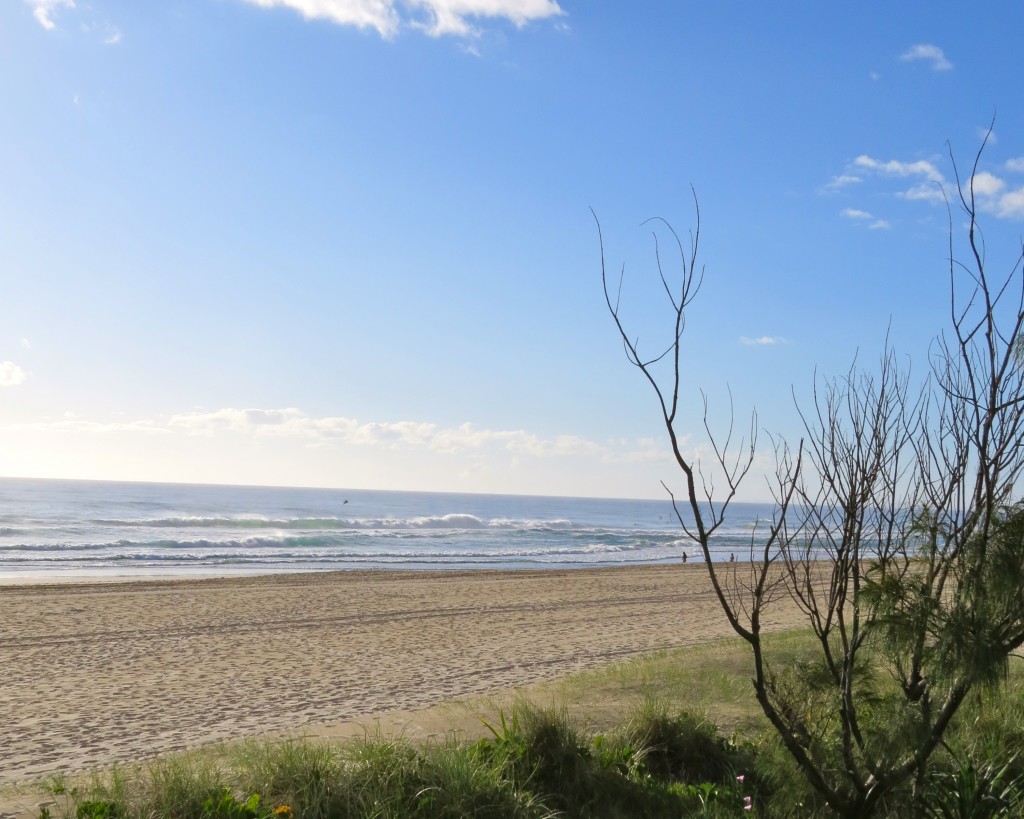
[595, 144, 1024, 817]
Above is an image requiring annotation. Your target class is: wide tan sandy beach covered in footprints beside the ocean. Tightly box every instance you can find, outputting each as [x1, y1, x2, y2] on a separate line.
[0, 564, 798, 784]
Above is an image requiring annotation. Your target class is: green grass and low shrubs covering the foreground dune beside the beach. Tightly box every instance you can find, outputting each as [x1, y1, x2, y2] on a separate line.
[19, 631, 1024, 819]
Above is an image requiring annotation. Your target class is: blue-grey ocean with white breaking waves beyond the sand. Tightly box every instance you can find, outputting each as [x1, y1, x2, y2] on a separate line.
[0, 478, 771, 581]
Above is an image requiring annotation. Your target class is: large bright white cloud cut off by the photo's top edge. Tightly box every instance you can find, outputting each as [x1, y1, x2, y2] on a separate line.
[235, 0, 565, 39]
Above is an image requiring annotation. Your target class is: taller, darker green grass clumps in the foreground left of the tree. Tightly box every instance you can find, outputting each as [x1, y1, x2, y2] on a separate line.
[41, 700, 754, 819]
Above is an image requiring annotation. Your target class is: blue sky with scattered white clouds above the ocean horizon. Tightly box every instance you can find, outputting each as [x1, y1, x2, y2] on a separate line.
[0, 0, 1024, 501]
